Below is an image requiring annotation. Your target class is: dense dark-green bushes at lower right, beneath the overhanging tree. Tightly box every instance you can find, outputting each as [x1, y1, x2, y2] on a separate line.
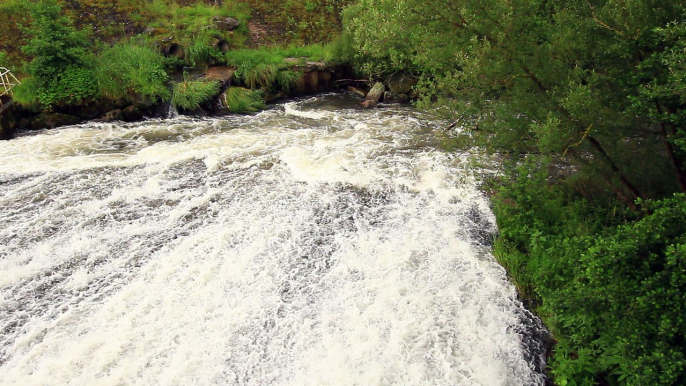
[495, 159, 686, 385]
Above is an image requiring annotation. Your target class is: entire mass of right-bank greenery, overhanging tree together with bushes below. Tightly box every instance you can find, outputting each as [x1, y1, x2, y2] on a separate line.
[345, 0, 686, 385]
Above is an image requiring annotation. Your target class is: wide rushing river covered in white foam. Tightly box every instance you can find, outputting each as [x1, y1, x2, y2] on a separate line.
[0, 94, 544, 386]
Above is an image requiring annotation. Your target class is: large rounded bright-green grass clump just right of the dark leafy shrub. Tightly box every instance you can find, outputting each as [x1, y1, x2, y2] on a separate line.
[95, 42, 171, 101]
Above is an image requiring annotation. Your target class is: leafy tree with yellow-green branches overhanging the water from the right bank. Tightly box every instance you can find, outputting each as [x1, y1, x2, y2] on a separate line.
[346, 0, 686, 206]
